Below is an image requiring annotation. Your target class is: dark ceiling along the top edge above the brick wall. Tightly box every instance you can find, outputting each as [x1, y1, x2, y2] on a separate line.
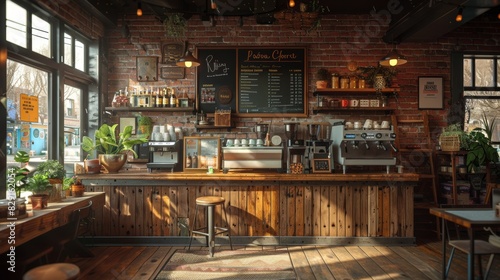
[84, 0, 500, 43]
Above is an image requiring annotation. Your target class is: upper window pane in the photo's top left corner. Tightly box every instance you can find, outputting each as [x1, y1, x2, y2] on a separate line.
[6, 1, 27, 48]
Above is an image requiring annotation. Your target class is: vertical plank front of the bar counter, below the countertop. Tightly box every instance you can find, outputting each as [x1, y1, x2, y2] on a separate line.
[92, 181, 414, 237]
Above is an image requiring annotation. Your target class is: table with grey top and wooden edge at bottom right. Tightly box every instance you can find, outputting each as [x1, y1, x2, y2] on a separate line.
[430, 208, 500, 280]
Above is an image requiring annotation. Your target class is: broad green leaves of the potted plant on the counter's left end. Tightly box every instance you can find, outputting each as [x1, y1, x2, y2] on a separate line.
[82, 124, 148, 156]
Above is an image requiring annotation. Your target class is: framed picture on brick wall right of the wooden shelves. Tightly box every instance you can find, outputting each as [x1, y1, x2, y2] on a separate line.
[418, 76, 444, 110]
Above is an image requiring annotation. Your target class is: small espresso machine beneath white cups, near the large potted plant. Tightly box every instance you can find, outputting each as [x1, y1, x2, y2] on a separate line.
[146, 140, 183, 173]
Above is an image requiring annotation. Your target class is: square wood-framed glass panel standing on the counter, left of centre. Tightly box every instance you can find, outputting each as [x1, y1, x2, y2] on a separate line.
[183, 136, 221, 172]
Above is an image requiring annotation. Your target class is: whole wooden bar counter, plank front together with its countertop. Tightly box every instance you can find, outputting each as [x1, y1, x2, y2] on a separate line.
[79, 172, 418, 242]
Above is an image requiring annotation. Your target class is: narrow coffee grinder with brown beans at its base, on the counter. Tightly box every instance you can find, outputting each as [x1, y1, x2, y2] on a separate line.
[285, 122, 306, 174]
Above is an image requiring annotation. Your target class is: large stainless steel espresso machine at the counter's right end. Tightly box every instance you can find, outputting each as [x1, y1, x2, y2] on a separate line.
[331, 122, 397, 174]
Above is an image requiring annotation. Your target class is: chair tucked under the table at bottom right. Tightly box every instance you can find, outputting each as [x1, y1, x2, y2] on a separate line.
[441, 204, 500, 279]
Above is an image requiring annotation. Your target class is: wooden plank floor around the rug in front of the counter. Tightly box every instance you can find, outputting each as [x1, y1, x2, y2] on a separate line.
[69, 238, 500, 280]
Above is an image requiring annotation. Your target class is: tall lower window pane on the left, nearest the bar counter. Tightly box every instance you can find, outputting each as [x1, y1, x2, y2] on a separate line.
[64, 85, 82, 174]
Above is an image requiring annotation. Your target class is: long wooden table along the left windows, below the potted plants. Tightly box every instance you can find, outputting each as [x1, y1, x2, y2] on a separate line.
[0, 192, 105, 253]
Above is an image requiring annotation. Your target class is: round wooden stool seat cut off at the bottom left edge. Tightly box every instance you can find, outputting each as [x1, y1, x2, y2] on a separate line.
[23, 263, 80, 280]
